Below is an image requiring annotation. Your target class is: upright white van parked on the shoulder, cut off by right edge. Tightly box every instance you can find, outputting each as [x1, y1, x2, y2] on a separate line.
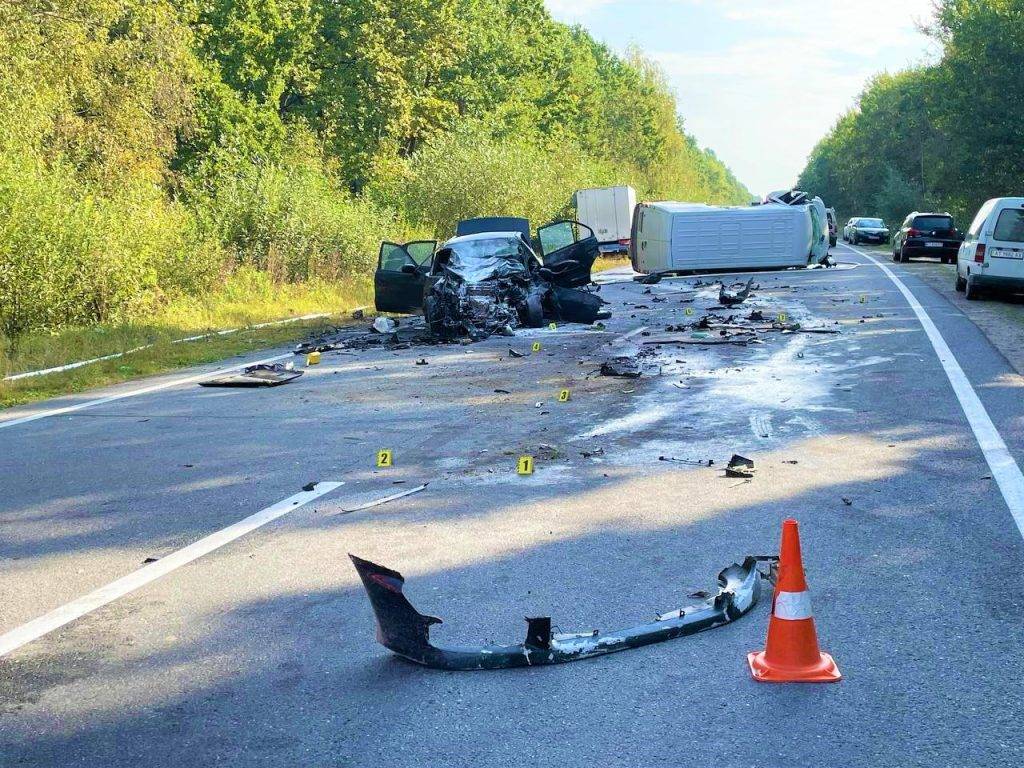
[956, 198, 1024, 299]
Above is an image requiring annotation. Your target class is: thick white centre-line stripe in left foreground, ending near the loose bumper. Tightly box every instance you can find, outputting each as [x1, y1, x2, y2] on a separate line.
[0, 482, 344, 656]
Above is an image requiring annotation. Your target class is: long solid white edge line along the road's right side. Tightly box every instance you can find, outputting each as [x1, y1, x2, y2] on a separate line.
[845, 246, 1024, 537]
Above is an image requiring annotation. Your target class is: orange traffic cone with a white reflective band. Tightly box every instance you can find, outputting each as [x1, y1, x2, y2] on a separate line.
[746, 520, 842, 683]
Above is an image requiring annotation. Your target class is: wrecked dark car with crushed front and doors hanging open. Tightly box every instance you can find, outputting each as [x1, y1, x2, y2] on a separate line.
[374, 218, 607, 340]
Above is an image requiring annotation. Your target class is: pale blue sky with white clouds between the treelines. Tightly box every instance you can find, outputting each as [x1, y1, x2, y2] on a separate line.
[546, 0, 936, 195]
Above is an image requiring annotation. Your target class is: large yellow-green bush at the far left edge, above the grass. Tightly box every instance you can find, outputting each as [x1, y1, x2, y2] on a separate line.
[0, 147, 219, 337]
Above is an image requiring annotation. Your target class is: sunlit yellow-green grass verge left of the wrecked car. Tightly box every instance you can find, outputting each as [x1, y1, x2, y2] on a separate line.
[0, 274, 373, 408]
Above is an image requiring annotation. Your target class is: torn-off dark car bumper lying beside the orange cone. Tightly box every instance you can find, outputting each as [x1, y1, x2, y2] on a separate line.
[349, 555, 777, 670]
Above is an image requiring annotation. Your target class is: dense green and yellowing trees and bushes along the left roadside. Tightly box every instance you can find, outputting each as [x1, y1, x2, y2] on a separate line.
[0, 0, 748, 339]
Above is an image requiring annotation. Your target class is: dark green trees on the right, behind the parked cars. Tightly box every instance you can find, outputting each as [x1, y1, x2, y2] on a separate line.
[799, 0, 1024, 227]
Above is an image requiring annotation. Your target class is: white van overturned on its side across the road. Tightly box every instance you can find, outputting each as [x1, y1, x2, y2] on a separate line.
[630, 203, 816, 273]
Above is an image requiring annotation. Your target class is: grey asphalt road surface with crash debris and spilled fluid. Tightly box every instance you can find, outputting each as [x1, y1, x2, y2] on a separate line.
[0, 246, 1024, 768]
